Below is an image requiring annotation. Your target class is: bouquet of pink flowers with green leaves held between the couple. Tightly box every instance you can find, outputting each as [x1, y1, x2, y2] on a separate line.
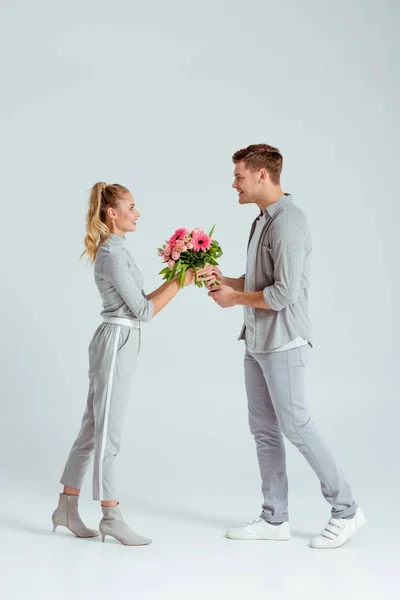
[158, 225, 223, 287]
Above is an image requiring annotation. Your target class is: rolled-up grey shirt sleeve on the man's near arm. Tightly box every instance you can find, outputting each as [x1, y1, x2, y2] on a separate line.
[263, 230, 306, 311]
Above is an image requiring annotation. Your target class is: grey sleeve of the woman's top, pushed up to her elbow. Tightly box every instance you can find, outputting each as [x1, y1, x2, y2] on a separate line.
[105, 252, 154, 323]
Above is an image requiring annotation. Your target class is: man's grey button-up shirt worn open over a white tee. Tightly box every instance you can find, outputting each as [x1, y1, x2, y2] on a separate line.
[239, 194, 312, 352]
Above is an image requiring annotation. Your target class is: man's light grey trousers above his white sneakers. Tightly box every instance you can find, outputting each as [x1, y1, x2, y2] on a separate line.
[244, 346, 357, 523]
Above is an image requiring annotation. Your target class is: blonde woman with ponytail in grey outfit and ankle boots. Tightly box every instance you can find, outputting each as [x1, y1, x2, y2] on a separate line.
[52, 183, 209, 546]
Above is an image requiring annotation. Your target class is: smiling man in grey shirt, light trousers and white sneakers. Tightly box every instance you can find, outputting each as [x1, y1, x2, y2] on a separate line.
[206, 144, 365, 548]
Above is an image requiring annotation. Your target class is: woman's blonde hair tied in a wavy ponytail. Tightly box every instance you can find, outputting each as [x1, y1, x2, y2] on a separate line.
[81, 181, 129, 262]
